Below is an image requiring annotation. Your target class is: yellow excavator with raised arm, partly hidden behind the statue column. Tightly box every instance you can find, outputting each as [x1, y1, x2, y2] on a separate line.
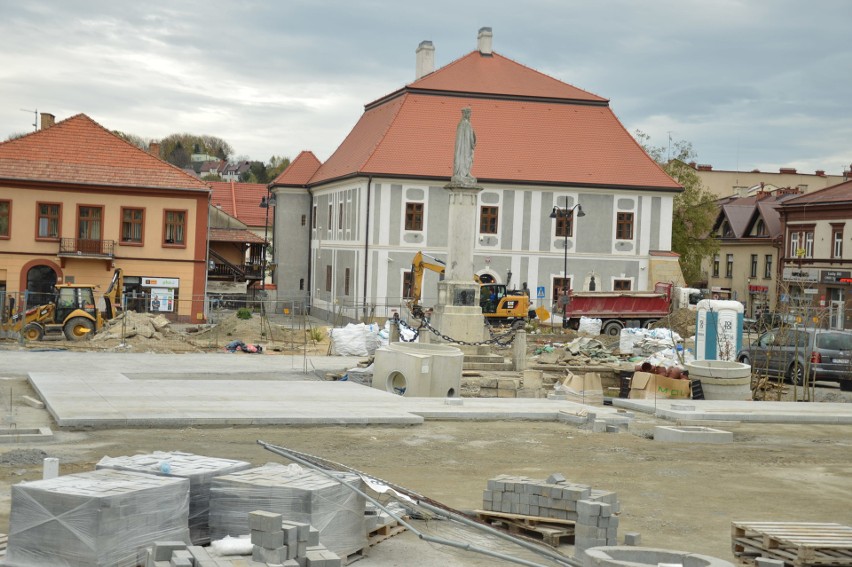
[406, 252, 535, 323]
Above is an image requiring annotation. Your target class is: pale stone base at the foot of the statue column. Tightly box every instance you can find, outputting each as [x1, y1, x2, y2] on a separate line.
[430, 281, 491, 343]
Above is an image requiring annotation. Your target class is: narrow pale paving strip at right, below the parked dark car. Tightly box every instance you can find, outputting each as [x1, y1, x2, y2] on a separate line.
[613, 398, 852, 424]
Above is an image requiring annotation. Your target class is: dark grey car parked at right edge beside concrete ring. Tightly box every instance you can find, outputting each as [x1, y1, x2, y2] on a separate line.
[737, 327, 852, 391]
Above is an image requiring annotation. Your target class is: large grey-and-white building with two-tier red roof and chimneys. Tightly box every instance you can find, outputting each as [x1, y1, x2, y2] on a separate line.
[270, 28, 682, 319]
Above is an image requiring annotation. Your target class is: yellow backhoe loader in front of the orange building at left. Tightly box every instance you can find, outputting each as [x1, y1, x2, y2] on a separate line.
[3, 268, 124, 341]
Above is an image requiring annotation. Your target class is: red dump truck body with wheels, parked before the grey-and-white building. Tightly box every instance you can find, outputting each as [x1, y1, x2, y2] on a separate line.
[563, 282, 672, 336]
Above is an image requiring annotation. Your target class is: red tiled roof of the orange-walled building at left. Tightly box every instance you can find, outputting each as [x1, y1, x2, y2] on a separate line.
[0, 114, 208, 191]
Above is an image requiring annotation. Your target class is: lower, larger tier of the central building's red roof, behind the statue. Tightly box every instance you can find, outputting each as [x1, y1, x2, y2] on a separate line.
[310, 93, 680, 190]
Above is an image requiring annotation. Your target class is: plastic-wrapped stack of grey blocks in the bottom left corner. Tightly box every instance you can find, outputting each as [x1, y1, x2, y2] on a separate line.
[6, 469, 189, 567]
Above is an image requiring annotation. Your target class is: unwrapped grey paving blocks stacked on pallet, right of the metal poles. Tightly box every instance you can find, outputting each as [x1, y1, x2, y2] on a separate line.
[482, 475, 620, 522]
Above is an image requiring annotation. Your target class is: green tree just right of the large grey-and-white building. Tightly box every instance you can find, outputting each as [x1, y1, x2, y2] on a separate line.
[635, 130, 719, 284]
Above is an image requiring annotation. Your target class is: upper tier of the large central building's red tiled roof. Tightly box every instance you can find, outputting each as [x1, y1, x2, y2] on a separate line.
[408, 51, 606, 102]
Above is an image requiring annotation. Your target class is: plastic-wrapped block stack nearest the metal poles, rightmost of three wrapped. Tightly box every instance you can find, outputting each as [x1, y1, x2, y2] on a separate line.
[210, 463, 367, 557]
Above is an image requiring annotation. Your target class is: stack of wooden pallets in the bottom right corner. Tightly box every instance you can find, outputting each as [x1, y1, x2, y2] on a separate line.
[731, 522, 852, 567]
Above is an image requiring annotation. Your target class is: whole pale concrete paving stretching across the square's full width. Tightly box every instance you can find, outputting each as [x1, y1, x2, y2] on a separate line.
[5, 350, 852, 428]
